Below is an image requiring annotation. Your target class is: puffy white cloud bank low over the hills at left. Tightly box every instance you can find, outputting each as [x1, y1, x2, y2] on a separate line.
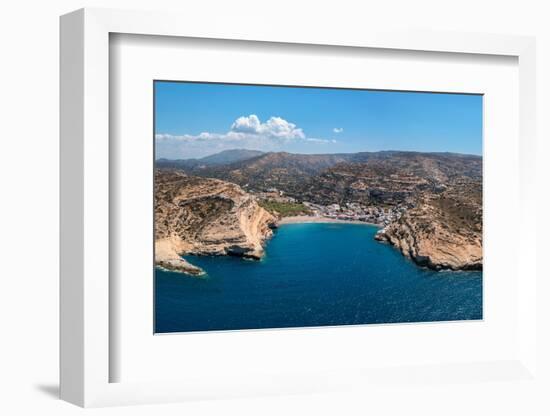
[155, 114, 336, 159]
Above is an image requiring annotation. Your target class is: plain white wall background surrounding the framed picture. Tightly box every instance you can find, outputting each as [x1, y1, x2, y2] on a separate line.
[0, 0, 550, 415]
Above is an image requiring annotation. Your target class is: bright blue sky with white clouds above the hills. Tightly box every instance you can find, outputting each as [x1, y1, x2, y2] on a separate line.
[155, 81, 482, 159]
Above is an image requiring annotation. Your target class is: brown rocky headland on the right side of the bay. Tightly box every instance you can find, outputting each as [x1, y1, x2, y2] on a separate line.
[375, 184, 483, 270]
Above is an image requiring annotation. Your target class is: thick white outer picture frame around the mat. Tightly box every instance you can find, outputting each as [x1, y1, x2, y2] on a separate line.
[60, 9, 537, 407]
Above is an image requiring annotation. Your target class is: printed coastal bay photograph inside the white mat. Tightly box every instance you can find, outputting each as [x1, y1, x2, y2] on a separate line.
[152, 80, 483, 334]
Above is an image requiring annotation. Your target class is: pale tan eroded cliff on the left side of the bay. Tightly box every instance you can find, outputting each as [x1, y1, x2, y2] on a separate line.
[155, 170, 276, 275]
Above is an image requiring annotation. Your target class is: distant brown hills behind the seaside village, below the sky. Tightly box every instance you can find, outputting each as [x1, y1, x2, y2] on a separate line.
[157, 151, 481, 204]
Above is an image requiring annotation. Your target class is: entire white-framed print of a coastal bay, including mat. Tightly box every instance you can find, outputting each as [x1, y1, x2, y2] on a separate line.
[61, 9, 537, 406]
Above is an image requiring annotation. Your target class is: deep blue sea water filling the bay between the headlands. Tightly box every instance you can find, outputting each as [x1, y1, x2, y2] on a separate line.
[155, 224, 482, 333]
